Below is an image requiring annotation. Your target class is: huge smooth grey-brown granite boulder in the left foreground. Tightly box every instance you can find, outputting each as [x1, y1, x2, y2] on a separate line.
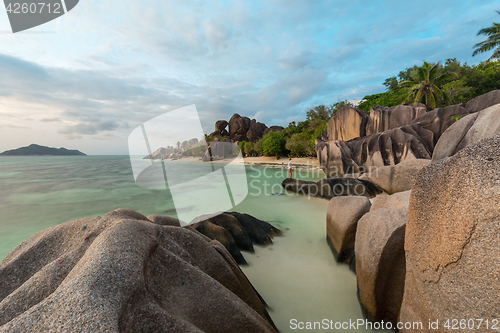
[0, 209, 276, 333]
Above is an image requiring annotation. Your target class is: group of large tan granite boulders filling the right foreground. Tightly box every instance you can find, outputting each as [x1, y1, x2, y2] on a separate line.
[326, 91, 500, 332]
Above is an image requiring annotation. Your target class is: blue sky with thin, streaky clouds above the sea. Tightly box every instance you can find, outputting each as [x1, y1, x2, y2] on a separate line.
[0, 0, 500, 155]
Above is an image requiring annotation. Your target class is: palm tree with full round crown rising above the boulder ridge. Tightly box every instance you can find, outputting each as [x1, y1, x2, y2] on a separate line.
[399, 61, 457, 109]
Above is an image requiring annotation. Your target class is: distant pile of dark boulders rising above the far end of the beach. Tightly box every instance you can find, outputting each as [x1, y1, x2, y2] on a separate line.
[209, 113, 283, 142]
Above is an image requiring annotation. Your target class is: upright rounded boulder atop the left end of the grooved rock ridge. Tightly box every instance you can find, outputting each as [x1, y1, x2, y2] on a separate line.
[326, 106, 368, 141]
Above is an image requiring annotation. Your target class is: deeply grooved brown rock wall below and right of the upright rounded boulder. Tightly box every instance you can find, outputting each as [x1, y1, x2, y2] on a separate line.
[316, 105, 467, 177]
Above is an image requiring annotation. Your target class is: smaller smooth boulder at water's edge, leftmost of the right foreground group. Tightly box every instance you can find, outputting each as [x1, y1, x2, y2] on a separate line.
[326, 196, 371, 265]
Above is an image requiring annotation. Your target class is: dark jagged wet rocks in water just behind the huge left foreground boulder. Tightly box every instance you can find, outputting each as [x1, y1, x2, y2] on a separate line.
[191, 212, 281, 264]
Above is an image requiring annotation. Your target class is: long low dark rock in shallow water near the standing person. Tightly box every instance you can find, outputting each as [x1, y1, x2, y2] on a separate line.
[281, 178, 382, 199]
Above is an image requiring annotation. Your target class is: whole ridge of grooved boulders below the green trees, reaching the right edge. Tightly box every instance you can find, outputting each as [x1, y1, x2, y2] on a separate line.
[316, 90, 500, 177]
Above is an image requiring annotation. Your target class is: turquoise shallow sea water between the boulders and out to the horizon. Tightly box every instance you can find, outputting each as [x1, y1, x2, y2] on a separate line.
[0, 156, 386, 332]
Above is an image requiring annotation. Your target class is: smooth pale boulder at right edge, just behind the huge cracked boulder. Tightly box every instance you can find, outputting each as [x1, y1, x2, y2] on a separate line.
[432, 102, 500, 161]
